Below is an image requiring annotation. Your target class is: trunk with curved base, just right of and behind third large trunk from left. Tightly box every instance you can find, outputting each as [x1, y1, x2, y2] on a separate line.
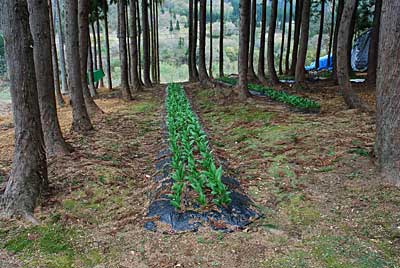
[78, 0, 103, 114]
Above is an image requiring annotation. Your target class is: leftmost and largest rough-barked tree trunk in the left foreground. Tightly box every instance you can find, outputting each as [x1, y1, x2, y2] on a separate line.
[0, 0, 47, 219]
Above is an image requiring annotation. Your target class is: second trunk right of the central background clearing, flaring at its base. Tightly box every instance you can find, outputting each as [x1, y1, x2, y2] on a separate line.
[199, 0, 209, 84]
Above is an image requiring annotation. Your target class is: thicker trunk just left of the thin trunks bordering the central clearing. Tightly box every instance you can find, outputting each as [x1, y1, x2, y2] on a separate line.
[142, 0, 151, 87]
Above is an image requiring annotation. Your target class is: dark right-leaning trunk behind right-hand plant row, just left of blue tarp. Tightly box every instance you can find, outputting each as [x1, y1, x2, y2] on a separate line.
[295, 0, 311, 88]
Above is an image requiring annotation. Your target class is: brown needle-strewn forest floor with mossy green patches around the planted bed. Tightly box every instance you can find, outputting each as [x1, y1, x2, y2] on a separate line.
[0, 82, 400, 268]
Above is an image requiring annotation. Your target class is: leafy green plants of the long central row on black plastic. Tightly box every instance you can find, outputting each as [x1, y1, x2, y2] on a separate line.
[166, 84, 231, 209]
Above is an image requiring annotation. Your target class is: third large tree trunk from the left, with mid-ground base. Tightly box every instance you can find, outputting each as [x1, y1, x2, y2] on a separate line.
[65, 0, 93, 132]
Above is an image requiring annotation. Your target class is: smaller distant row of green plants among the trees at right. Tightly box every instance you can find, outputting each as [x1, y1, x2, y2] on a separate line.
[218, 77, 321, 111]
